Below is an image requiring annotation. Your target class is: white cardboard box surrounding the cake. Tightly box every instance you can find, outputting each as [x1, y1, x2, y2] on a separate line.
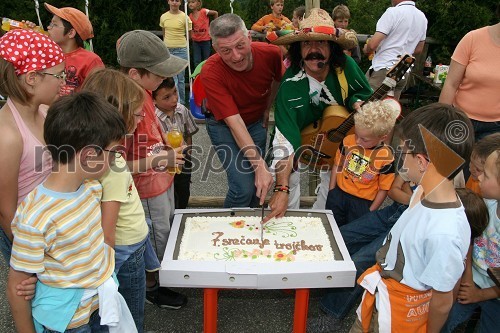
[160, 208, 356, 289]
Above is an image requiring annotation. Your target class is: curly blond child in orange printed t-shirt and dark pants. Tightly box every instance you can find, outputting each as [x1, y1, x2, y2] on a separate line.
[326, 101, 399, 227]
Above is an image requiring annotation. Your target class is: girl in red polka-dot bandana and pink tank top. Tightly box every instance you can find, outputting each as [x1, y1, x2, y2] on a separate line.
[0, 29, 66, 256]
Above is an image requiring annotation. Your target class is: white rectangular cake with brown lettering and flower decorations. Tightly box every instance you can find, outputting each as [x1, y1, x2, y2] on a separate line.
[177, 216, 334, 262]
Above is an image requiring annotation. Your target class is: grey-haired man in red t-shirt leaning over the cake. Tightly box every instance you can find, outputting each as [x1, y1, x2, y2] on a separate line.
[201, 14, 283, 208]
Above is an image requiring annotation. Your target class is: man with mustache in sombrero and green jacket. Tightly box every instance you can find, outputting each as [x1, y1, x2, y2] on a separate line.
[264, 8, 372, 222]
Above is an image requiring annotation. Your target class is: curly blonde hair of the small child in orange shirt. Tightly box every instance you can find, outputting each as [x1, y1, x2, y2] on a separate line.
[354, 101, 399, 137]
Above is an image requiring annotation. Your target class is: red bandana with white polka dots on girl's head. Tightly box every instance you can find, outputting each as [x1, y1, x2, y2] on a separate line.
[0, 29, 64, 75]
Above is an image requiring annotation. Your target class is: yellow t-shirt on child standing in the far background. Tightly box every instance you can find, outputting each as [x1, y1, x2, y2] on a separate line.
[160, 11, 193, 47]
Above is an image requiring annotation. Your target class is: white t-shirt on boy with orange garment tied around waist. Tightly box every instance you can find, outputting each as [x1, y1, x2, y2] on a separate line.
[377, 186, 470, 292]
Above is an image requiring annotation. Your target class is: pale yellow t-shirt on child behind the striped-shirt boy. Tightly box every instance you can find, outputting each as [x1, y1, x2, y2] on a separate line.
[101, 156, 149, 245]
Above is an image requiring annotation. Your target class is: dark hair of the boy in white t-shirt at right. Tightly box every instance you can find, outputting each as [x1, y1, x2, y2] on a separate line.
[397, 103, 474, 180]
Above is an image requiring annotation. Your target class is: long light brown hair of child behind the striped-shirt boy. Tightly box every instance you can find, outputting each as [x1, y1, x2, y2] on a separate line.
[82, 68, 145, 132]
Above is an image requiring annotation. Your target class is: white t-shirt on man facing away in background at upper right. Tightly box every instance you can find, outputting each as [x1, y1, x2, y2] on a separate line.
[371, 1, 427, 71]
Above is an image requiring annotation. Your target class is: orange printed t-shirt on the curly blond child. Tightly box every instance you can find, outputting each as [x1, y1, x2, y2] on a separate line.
[335, 134, 395, 201]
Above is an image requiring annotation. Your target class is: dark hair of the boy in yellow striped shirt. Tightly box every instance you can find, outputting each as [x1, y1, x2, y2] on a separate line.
[43, 92, 127, 164]
